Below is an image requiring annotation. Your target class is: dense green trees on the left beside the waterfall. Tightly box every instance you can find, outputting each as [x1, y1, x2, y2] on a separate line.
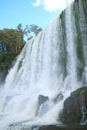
[0, 24, 25, 82]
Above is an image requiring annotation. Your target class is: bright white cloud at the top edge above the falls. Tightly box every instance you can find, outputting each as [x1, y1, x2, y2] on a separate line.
[33, 0, 73, 12]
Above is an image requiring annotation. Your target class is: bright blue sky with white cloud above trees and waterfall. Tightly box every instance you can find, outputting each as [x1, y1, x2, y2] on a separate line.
[0, 0, 71, 29]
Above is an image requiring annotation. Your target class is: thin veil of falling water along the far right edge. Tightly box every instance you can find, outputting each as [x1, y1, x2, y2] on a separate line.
[79, 0, 87, 84]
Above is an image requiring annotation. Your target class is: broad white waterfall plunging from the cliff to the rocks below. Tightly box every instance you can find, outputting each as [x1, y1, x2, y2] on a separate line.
[0, 0, 86, 130]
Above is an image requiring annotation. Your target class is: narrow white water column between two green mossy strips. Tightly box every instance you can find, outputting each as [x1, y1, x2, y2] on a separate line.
[65, 2, 78, 90]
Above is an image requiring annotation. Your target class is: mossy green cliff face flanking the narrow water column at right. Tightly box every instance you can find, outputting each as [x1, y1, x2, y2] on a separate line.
[60, 0, 87, 83]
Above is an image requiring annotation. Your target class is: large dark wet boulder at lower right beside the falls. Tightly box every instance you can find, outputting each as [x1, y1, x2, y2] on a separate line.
[60, 87, 87, 124]
